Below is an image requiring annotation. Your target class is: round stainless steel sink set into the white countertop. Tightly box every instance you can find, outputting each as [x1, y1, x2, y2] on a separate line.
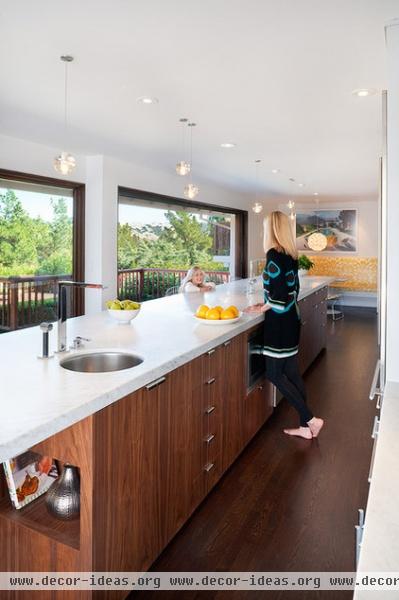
[60, 351, 143, 373]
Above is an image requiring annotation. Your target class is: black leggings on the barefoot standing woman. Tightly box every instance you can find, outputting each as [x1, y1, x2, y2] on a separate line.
[266, 355, 313, 427]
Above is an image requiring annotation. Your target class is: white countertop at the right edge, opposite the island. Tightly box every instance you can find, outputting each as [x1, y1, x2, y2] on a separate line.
[354, 383, 399, 600]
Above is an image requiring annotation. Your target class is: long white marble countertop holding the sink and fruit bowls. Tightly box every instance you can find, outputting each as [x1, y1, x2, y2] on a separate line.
[0, 277, 333, 462]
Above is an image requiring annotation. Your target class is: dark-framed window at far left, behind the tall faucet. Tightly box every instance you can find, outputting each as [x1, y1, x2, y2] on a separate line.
[0, 171, 84, 333]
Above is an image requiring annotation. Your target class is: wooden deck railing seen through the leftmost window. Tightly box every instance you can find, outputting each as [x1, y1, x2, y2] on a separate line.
[0, 275, 72, 332]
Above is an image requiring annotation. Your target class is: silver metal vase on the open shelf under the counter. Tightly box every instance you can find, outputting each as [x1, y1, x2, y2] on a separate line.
[46, 463, 80, 521]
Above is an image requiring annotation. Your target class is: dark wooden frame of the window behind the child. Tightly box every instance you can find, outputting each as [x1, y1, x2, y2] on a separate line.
[118, 186, 248, 278]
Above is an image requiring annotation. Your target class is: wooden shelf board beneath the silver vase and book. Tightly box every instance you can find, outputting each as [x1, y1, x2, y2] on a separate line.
[0, 494, 80, 550]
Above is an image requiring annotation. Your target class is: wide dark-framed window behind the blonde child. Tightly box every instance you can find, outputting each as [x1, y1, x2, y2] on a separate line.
[118, 189, 246, 300]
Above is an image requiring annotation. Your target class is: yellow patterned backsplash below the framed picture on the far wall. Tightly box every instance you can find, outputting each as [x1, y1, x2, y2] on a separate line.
[309, 255, 378, 292]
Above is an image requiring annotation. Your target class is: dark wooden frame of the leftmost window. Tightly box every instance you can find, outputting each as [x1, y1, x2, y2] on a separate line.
[0, 169, 86, 316]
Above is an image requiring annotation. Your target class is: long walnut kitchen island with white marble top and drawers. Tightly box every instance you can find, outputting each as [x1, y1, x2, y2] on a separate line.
[0, 277, 330, 599]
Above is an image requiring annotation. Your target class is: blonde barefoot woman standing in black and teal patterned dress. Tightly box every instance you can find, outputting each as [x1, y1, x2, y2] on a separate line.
[246, 211, 324, 439]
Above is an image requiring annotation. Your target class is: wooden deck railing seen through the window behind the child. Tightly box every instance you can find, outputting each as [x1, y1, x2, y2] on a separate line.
[118, 269, 230, 302]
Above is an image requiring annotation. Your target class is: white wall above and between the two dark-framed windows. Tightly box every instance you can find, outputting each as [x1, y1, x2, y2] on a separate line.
[0, 136, 253, 313]
